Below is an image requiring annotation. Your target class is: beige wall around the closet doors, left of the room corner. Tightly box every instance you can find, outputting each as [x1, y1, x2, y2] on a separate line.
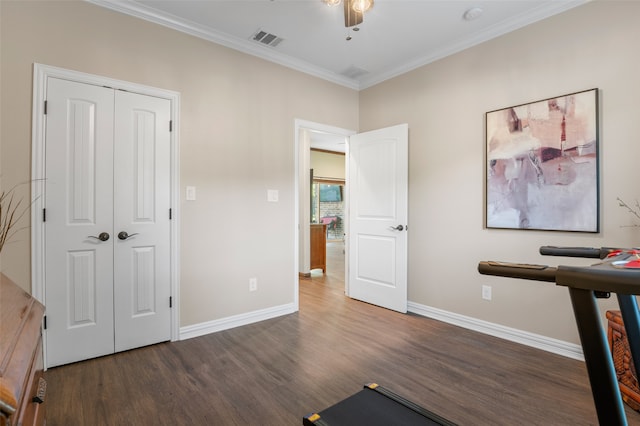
[0, 0, 358, 326]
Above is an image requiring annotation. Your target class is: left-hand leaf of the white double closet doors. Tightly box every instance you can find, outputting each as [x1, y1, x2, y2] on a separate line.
[45, 78, 114, 366]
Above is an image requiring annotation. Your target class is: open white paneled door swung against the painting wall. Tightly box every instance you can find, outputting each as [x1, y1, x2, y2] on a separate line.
[348, 124, 409, 312]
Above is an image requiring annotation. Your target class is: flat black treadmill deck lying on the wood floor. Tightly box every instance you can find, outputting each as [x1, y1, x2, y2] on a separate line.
[302, 383, 456, 426]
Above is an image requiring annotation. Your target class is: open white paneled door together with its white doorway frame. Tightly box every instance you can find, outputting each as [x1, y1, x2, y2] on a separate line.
[294, 121, 409, 312]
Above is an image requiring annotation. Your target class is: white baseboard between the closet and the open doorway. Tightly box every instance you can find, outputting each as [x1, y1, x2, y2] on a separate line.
[180, 303, 296, 340]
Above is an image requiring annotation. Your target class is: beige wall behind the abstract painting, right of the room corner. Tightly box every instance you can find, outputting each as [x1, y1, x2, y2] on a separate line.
[360, 1, 640, 343]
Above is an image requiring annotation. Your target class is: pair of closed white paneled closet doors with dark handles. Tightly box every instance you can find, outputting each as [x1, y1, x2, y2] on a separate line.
[45, 78, 171, 367]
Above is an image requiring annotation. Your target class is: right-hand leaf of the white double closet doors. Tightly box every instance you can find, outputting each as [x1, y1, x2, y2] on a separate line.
[114, 92, 171, 352]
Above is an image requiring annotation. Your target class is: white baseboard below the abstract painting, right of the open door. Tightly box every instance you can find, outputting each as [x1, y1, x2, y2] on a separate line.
[407, 302, 584, 361]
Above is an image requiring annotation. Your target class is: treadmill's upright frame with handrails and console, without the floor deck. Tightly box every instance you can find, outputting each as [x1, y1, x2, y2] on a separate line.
[478, 246, 640, 425]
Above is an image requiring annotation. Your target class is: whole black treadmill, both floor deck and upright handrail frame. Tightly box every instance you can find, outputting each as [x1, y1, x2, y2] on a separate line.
[302, 246, 640, 426]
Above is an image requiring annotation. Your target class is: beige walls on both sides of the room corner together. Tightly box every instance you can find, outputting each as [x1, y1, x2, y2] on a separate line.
[0, 0, 640, 343]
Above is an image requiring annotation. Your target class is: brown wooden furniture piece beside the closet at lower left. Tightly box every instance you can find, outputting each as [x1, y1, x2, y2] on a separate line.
[0, 274, 46, 426]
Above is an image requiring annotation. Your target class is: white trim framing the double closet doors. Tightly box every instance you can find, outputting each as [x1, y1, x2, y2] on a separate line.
[31, 63, 180, 356]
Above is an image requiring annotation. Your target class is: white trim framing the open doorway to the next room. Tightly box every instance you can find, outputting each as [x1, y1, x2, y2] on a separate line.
[293, 118, 357, 311]
